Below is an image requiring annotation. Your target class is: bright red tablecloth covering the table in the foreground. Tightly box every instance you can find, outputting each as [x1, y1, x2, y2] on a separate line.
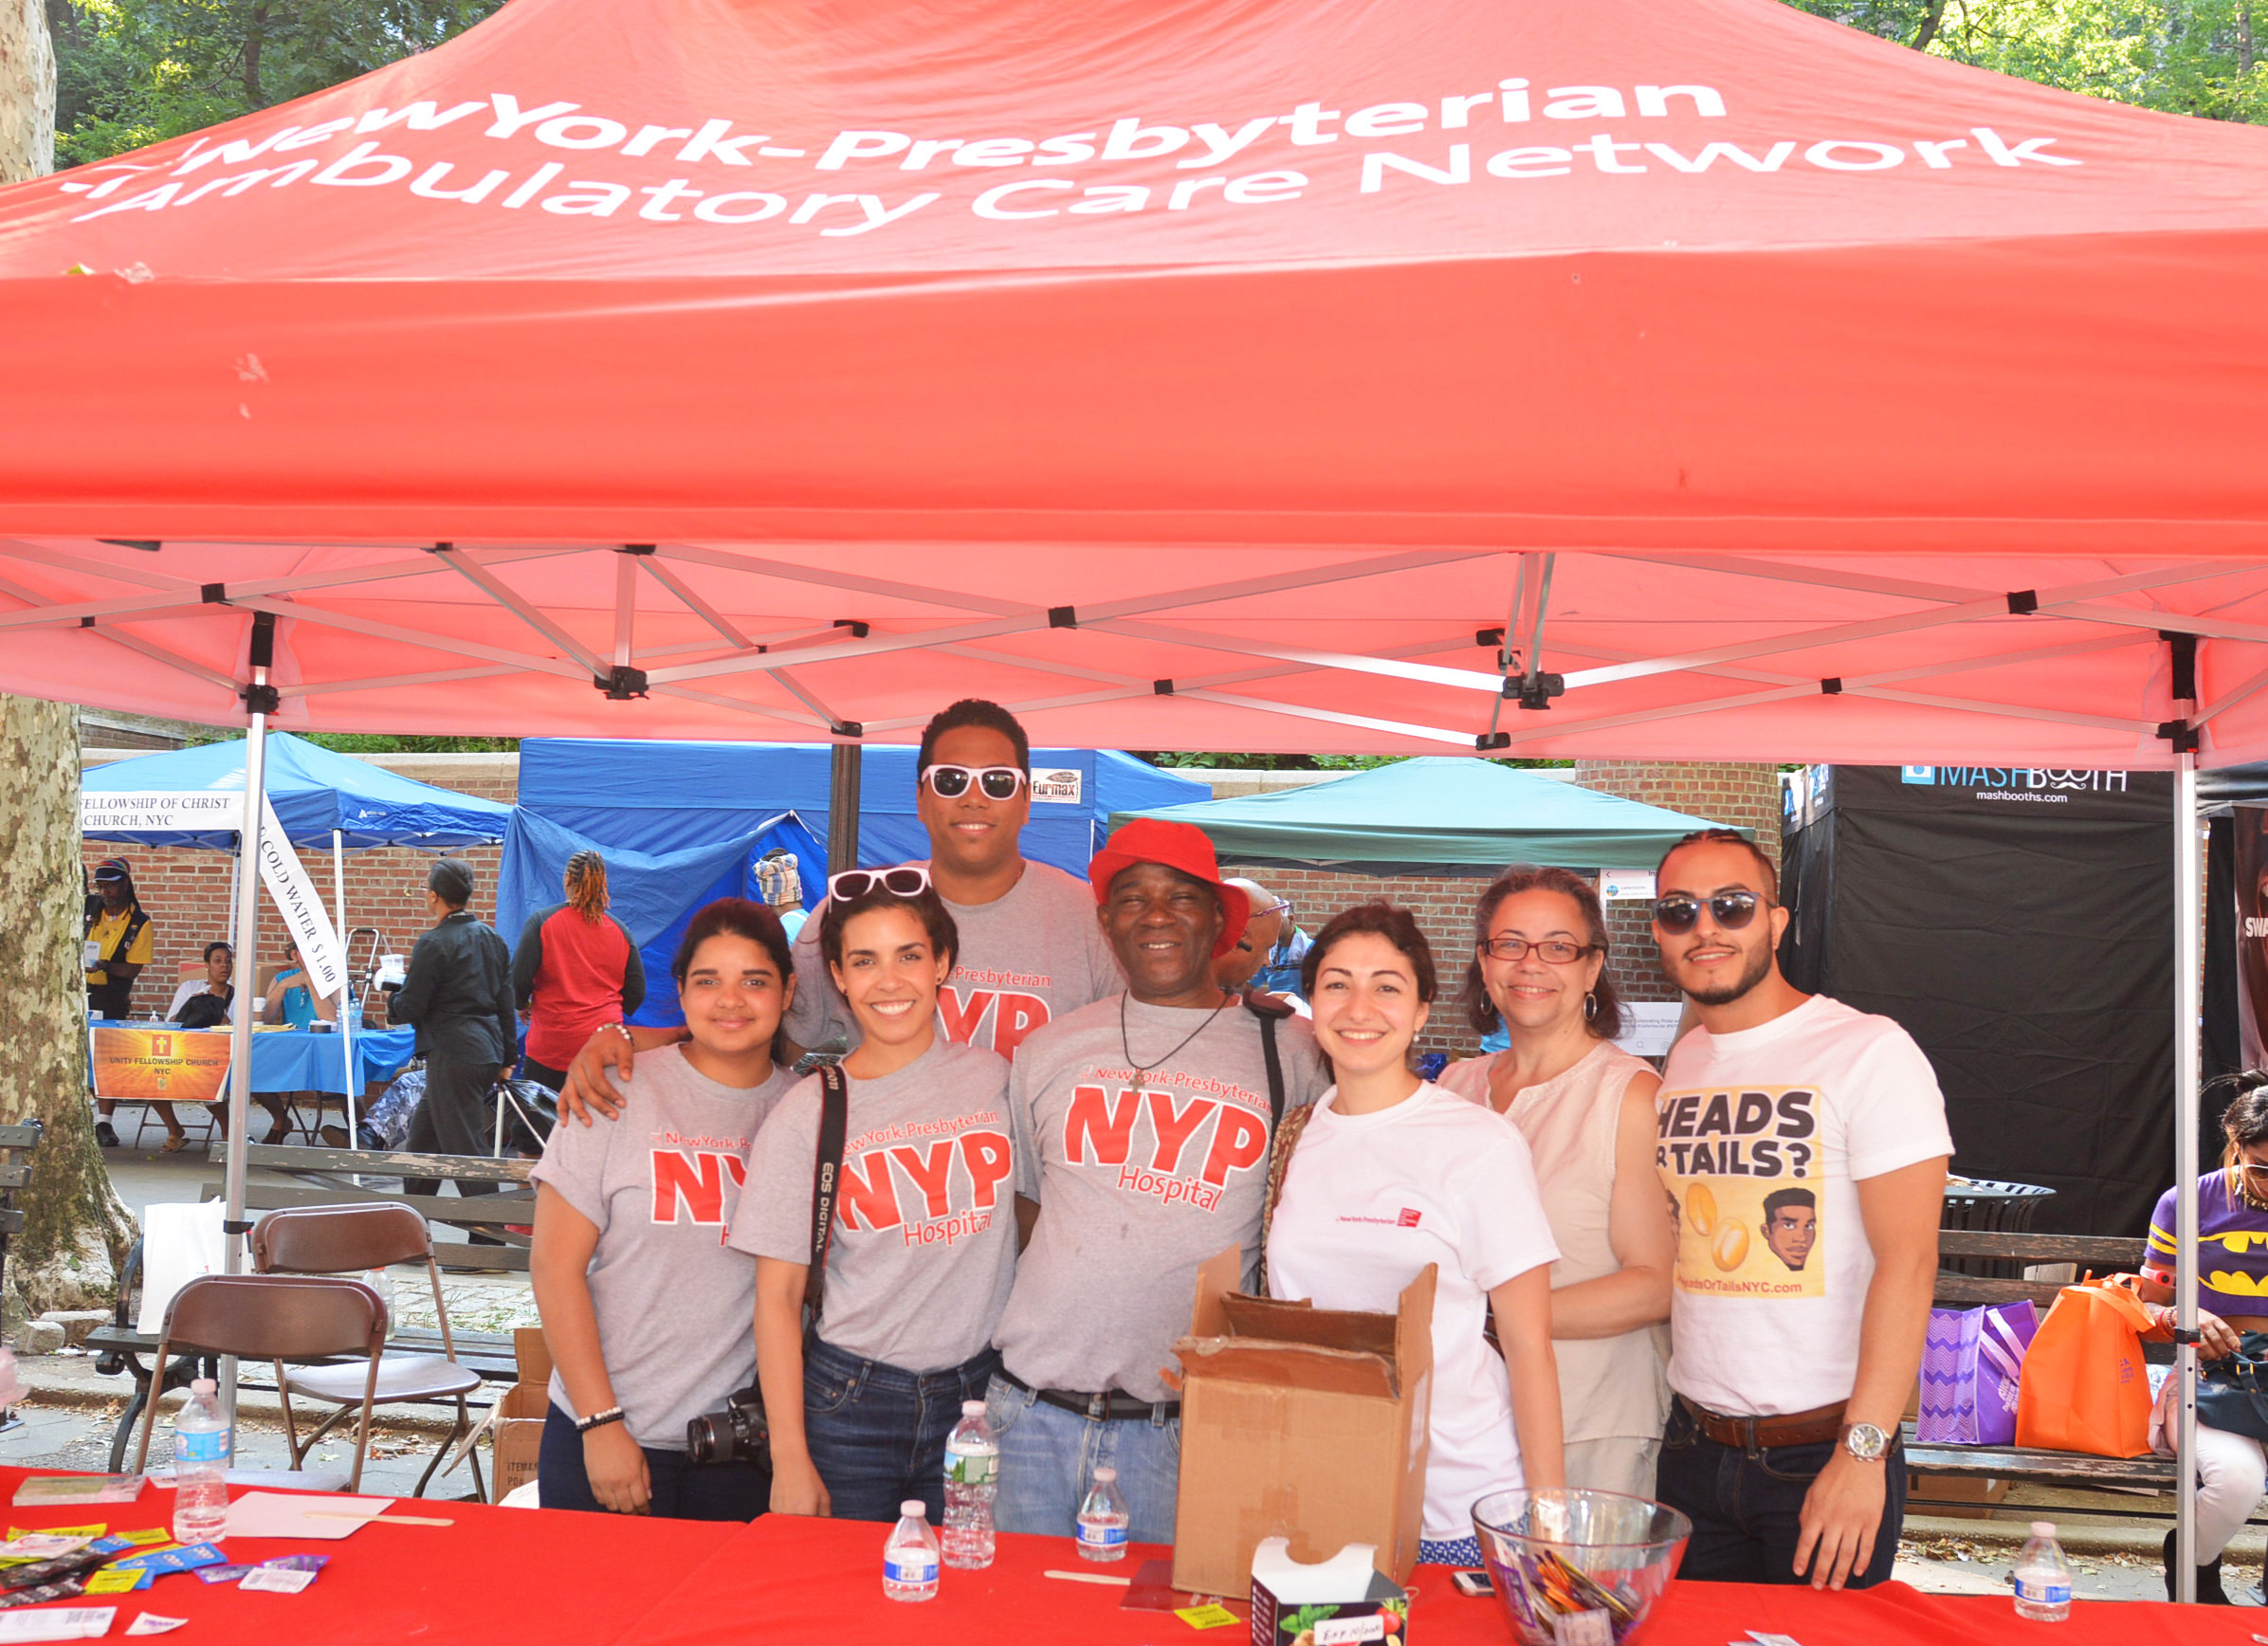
[0, 1469, 2259, 1646]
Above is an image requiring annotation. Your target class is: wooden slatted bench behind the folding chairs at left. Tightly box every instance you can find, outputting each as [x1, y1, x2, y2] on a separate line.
[93, 1146, 536, 1472]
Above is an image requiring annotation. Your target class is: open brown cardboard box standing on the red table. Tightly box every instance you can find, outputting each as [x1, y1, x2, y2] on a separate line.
[1173, 1247, 1434, 1594]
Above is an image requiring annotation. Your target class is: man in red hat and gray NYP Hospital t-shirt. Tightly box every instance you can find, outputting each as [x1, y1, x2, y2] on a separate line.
[989, 818, 1329, 1544]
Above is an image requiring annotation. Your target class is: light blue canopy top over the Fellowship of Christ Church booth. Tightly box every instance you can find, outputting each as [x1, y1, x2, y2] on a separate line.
[80, 732, 513, 852]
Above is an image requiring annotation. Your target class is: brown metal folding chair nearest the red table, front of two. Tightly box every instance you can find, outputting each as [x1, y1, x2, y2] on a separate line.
[134, 1274, 386, 1491]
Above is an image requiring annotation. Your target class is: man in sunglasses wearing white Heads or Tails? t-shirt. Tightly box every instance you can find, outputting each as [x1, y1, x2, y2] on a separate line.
[1654, 830, 1953, 1589]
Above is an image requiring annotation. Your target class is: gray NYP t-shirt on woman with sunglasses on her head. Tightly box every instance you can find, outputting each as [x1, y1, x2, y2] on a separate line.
[733, 1041, 1016, 1372]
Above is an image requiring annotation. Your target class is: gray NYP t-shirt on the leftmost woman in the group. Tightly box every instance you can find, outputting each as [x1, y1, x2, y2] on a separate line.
[528, 1045, 796, 1451]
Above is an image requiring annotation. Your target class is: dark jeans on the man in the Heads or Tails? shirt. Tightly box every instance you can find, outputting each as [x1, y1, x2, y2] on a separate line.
[1654, 1401, 1905, 1589]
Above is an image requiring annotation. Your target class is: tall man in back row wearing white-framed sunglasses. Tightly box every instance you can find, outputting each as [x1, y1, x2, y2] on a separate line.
[560, 698, 1121, 1123]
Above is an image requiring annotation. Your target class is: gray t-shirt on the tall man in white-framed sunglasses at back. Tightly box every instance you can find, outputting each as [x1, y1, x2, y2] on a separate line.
[787, 862, 1125, 1056]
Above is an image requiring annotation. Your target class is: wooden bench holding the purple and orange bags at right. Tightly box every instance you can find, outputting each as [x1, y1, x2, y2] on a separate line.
[1905, 1229, 2231, 1519]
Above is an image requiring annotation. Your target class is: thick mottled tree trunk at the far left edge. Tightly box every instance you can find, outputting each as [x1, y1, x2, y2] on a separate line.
[0, 0, 134, 1312]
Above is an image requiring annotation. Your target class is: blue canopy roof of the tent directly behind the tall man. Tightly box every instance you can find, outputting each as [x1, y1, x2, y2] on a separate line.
[520, 737, 1214, 884]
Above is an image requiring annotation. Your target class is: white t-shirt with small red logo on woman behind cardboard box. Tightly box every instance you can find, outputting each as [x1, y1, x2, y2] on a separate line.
[1268, 1082, 1558, 1540]
